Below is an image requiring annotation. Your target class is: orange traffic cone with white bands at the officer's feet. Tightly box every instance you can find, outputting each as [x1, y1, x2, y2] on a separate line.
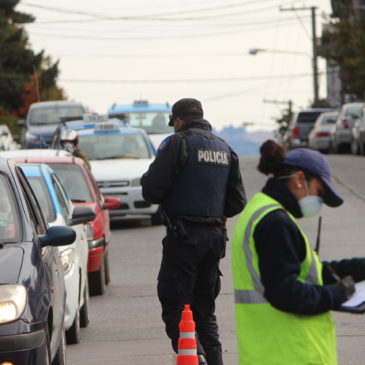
[176, 304, 199, 365]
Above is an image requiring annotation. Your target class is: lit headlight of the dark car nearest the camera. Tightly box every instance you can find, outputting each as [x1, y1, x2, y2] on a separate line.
[0, 284, 27, 323]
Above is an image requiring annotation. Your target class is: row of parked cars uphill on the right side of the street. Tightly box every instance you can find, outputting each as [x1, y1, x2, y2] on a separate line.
[280, 102, 365, 155]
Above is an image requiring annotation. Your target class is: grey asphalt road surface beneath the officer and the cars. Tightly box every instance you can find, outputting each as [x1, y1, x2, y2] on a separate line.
[67, 155, 365, 365]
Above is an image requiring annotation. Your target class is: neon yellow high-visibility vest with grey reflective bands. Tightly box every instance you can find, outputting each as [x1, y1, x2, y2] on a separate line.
[232, 193, 337, 365]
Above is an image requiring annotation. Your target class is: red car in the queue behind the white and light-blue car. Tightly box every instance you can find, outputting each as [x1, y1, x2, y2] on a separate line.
[4, 150, 121, 295]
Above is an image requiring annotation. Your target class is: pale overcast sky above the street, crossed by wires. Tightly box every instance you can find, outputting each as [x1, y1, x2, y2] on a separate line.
[17, 0, 330, 130]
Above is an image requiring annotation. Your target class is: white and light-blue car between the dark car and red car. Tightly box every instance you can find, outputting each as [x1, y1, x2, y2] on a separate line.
[19, 164, 95, 344]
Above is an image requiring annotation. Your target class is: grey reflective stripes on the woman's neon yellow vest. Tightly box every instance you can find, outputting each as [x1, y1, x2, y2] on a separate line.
[234, 200, 318, 303]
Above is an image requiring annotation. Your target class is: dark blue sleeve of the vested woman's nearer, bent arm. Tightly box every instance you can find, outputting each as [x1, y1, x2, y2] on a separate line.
[254, 210, 346, 315]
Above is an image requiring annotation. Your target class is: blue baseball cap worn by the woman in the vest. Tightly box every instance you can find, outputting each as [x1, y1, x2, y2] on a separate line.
[283, 148, 343, 207]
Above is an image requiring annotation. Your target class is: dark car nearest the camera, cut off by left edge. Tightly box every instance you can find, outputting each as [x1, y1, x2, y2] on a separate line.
[0, 159, 76, 365]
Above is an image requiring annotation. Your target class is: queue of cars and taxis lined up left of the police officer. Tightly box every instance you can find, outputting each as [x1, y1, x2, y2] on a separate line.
[0, 97, 172, 365]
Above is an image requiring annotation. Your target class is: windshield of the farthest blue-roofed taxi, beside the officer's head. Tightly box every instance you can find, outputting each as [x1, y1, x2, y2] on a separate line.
[116, 112, 173, 134]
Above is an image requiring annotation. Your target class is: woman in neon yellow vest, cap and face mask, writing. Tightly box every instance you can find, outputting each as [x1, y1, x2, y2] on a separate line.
[231, 140, 365, 365]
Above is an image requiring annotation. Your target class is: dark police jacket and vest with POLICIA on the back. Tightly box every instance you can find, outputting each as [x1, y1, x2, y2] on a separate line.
[141, 119, 246, 221]
